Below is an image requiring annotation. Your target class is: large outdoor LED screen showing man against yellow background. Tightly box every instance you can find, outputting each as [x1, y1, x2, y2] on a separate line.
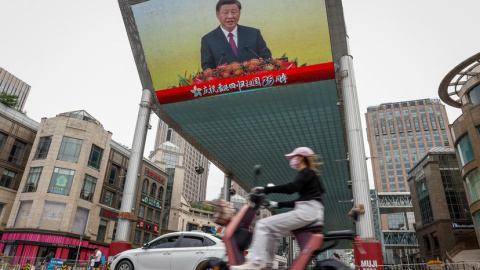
[131, 0, 334, 104]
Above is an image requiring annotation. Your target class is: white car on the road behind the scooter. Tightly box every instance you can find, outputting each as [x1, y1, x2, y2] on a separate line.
[111, 232, 225, 270]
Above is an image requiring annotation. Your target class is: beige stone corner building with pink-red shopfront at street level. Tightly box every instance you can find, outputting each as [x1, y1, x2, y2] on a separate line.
[0, 108, 167, 265]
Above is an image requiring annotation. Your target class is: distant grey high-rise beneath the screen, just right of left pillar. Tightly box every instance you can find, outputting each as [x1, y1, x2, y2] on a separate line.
[150, 120, 209, 202]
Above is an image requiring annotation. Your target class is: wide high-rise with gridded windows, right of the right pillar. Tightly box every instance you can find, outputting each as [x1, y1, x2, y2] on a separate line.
[365, 99, 453, 263]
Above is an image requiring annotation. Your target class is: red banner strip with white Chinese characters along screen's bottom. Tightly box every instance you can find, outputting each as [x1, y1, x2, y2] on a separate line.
[156, 62, 335, 104]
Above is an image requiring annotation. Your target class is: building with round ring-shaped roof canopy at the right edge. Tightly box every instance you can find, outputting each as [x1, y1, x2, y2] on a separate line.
[438, 53, 480, 246]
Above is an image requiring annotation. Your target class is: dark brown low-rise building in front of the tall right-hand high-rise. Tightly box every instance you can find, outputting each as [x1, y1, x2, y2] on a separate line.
[408, 147, 478, 261]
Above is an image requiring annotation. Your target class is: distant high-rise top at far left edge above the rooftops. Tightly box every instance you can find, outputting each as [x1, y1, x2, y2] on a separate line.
[0, 67, 30, 111]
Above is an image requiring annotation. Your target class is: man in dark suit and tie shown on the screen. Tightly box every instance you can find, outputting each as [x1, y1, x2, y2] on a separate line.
[201, 0, 272, 70]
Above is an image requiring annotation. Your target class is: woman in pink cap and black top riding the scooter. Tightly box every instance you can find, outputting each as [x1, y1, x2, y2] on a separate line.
[230, 147, 324, 270]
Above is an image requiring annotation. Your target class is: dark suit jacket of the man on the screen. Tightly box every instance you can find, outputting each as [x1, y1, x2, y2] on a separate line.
[201, 25, 272, 70]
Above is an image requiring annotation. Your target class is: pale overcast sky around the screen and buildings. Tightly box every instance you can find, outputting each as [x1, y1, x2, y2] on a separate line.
[0, 0, 480, 199]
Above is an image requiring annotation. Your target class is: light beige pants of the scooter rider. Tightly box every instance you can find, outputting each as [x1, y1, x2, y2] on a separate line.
[246, 200, 324, 265]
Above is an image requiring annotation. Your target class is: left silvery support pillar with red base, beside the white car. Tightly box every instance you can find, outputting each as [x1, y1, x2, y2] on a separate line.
[109, 89, 152, 256]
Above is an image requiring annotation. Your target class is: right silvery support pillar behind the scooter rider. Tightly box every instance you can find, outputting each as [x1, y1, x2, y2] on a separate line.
[340, 55, 375, 239]
